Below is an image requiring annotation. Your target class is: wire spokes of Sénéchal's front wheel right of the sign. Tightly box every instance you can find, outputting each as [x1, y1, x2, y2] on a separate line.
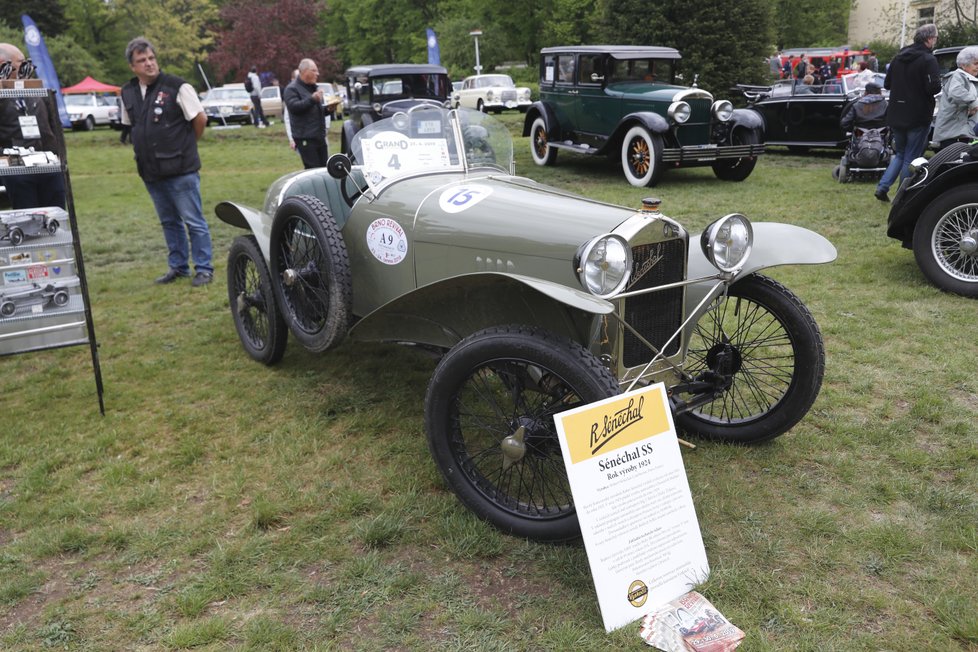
[687, 290, 795, 423]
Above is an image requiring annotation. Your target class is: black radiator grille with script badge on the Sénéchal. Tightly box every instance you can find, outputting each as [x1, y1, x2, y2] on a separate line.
[622, 239, 686, 367]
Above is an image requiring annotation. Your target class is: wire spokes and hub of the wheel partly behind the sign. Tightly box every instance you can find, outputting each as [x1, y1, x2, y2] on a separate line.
[451, 360, 582, 519]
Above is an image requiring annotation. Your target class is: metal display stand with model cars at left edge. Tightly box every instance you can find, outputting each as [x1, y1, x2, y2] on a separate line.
[0, 88, 105, 415]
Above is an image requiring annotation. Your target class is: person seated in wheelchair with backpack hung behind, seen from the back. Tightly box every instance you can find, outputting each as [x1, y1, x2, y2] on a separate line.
[832, 82, 893, 183]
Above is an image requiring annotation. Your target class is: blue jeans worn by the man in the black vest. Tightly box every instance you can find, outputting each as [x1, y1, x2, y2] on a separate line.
[144, 172, 214, 275]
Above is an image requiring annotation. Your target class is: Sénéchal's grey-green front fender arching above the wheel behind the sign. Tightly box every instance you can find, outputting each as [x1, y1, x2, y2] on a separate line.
[350, 273, 614, 349]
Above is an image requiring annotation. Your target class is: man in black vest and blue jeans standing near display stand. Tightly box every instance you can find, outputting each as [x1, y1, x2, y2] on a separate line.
[121, 37, 214, 287]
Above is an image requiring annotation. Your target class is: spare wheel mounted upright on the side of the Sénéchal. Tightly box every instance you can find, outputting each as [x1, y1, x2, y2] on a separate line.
[270, 195, 353, 353]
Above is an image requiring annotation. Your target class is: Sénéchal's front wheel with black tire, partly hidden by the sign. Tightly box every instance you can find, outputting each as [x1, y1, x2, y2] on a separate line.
[425, 325, 619, 542]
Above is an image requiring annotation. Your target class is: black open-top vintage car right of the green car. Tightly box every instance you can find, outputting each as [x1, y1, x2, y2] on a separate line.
[737, 73, 886, 151]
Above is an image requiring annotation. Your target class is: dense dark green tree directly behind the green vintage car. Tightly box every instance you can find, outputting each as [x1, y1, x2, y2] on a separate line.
[598, 0, 772, 97]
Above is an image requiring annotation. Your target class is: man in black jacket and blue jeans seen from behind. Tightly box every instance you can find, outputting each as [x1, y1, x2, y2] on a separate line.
[874, 24, 941, 202]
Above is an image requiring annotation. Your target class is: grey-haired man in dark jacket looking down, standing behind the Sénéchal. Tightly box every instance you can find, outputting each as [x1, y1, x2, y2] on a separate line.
[282, 59, 328, 170]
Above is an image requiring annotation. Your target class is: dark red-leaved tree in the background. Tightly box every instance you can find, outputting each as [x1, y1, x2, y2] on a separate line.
[210, 0, 342, 86]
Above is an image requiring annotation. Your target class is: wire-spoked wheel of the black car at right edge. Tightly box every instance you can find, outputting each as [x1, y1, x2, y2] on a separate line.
[913, 183, 978, 299]
